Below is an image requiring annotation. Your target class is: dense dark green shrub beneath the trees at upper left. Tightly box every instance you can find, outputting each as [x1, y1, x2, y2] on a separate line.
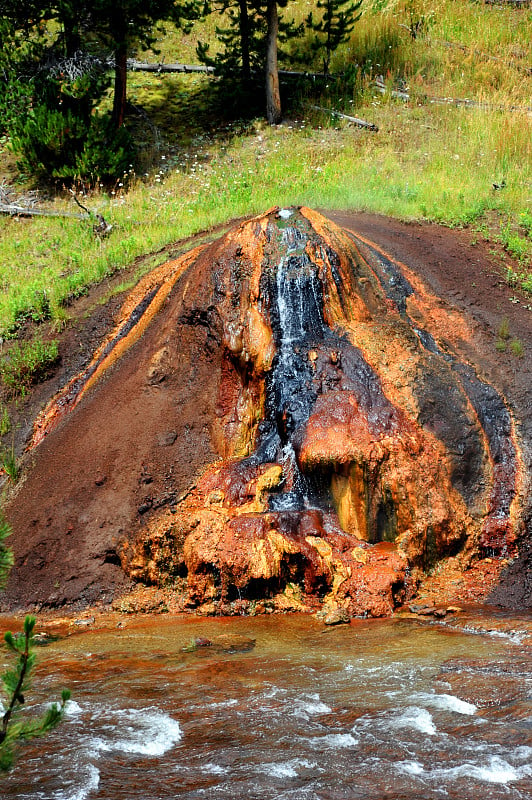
[0, 48, 133, 185]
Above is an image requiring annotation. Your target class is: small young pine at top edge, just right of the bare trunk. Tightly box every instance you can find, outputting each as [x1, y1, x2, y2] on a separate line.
[306, 0, 362, 75]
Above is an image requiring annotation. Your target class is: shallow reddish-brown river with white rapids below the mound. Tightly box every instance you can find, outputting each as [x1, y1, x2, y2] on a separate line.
[0, 615, 532, 800]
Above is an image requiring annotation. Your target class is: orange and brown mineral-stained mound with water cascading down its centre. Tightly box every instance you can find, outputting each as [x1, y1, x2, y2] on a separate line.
[3, 208, 527, 616]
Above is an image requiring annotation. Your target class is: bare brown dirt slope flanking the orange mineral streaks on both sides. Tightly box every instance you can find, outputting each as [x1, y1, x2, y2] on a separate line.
[3, 212, 532, 608]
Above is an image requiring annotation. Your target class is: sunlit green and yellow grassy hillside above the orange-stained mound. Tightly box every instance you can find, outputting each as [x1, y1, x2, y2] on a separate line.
[0, 0, 532, 336]
